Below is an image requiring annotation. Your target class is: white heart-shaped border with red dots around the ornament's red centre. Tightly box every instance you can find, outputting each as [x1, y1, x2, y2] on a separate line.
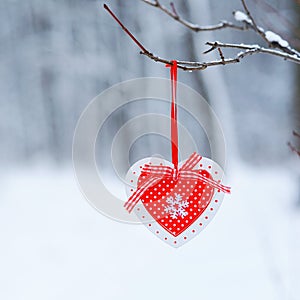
[125, 157, 224, 248]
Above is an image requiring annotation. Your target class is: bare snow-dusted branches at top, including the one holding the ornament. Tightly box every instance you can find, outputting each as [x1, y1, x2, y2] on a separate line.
[104, 0, 300, 71]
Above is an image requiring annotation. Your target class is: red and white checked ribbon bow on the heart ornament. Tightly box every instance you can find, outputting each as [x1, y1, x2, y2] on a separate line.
[124, 152, 230, 213]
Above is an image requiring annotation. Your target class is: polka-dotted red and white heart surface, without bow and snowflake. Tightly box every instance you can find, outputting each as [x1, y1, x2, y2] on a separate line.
[126, 157, 224, 248]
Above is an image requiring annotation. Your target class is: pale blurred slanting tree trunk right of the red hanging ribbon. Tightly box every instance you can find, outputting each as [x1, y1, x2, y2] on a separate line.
[178, 0, 239, 164]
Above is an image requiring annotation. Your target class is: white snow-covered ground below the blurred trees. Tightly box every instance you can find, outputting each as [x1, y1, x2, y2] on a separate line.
[0, 166, 300, 300]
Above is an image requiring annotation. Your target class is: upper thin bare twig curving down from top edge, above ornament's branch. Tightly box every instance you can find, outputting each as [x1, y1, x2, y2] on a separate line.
[141, 0, 246, 32]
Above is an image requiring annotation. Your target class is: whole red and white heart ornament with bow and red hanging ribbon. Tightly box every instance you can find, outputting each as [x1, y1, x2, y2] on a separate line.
[124, 61, 230, 247]
